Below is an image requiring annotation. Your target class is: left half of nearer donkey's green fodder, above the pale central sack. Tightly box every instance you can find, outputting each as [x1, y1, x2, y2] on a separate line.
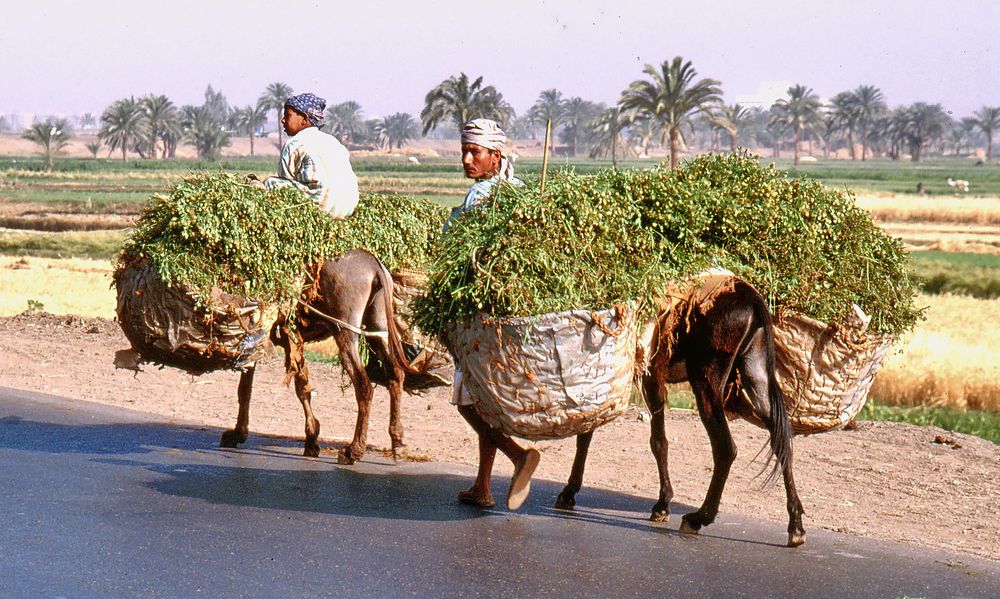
[414, 171, 708, 336]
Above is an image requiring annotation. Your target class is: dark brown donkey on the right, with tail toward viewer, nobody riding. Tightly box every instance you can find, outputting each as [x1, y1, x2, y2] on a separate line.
[555, 277, 806, 547]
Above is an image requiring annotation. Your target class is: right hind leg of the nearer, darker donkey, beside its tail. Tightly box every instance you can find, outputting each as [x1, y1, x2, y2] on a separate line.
[739, 352, 806, 547]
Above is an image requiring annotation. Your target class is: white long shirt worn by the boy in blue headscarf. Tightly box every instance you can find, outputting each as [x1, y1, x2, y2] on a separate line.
[264, 127, 359, 218]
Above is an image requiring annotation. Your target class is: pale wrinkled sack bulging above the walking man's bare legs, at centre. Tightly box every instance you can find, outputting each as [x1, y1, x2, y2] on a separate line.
[446, 308, 636, 439]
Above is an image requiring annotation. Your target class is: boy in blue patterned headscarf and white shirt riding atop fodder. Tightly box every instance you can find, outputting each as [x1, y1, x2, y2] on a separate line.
[252, 93, 359, 219]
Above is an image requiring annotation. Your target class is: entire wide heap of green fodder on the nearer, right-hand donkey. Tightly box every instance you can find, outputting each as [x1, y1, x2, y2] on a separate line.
[415, 154, 920, 334]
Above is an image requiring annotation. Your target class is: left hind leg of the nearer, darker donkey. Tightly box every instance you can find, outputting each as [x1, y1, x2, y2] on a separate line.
[680, 362, 736, 533]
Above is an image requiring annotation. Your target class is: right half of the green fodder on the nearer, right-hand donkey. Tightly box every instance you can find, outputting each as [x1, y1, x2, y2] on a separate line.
[656, 154, 921, 335]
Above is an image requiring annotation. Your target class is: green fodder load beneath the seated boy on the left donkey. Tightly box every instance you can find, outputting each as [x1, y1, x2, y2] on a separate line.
[116, 174, 447, 305]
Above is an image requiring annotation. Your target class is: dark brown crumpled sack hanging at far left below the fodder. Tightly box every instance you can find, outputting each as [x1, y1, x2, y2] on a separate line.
[114, 260, 277, 374]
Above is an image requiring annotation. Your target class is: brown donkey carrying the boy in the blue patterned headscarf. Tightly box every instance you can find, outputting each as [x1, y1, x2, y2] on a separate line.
[219, 250, 416, 464]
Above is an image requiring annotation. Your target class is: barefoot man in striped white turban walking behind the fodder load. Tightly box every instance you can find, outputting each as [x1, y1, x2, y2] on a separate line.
[445, 119, 540, 510]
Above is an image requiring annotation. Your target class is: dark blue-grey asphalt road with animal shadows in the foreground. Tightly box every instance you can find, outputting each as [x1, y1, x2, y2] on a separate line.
[0, 388, 1000, 598]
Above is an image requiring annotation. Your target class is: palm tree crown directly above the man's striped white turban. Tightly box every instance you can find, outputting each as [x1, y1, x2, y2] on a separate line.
[420, 73, 513, 135]
